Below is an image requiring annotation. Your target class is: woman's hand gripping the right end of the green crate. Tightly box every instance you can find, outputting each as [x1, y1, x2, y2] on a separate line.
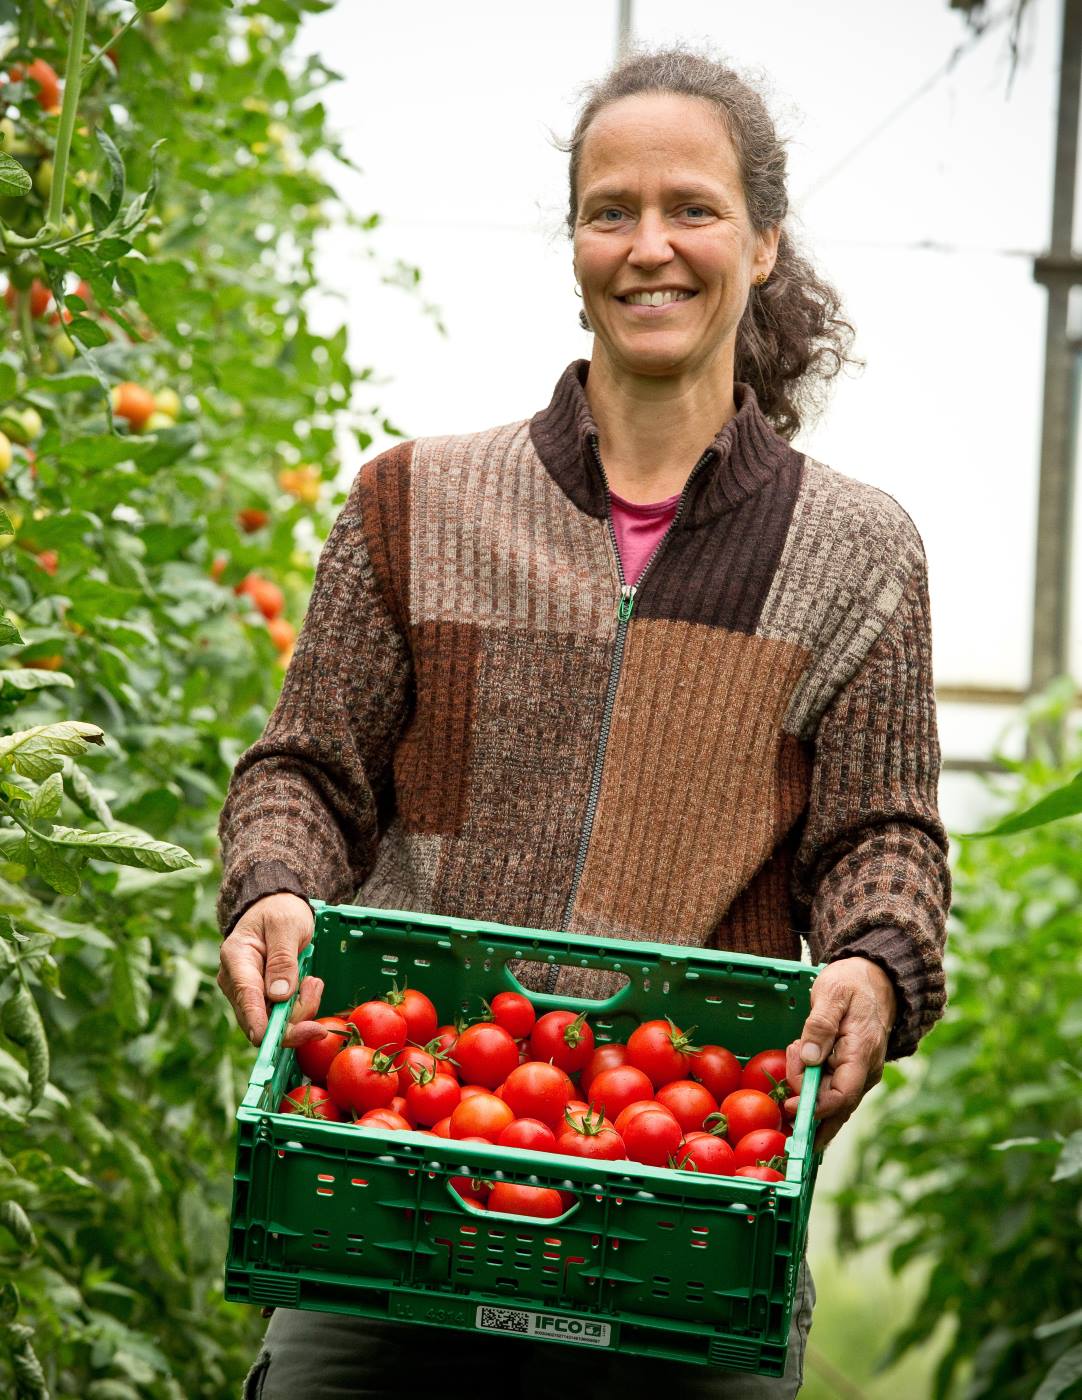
[784, 958, 897, 1151]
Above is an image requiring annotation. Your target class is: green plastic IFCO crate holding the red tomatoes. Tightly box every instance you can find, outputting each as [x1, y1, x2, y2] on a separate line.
[225, 900, 819, 1376]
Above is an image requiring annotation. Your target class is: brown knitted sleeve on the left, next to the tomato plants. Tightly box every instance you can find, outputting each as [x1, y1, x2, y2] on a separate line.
[217, 454, 413, 937]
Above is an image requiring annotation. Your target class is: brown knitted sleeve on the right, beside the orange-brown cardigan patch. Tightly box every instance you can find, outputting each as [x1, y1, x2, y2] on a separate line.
[794, 550, 950, 1058]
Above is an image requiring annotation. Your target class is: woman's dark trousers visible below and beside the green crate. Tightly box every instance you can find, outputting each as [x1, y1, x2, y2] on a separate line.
[244, 1260, 815, 1400]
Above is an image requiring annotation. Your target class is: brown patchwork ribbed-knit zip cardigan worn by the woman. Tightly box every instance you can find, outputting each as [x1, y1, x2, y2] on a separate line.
[218, 361, 950, 1057]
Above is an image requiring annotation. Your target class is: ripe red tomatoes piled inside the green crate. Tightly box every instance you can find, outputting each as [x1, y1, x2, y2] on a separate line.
[279, 987, 792, 1217]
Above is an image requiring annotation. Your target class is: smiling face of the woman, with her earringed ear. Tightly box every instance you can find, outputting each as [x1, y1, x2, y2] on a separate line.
[574, 92, 778, 377]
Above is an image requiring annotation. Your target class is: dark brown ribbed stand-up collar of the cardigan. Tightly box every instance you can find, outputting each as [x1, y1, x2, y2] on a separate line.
[529, 360, 798, 529]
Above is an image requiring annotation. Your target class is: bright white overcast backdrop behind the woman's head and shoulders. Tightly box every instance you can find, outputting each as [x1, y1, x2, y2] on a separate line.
[291, 0, 1082, 829]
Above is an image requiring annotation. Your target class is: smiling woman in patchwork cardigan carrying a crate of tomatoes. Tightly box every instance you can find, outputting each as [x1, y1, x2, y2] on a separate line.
[220, 50, 949, 1397]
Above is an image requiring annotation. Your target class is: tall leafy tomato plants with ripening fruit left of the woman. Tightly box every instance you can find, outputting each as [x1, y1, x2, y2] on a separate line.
[0, 0, 425, 1400]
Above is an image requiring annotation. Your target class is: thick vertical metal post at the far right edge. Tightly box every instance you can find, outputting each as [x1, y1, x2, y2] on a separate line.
[1030, 0, 1082, 756]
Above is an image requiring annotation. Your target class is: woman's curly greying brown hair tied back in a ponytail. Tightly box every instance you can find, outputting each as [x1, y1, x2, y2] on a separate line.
[560, 48, 859, 438]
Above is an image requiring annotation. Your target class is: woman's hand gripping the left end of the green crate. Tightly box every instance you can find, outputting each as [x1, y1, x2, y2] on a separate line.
[218, 893, 326, 1046]
